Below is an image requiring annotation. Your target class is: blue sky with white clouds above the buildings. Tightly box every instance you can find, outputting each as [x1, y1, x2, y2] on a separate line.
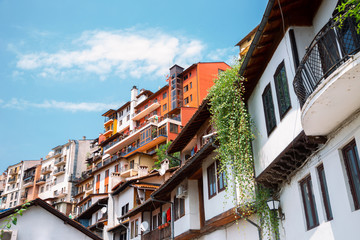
[0, 0, 267, 171]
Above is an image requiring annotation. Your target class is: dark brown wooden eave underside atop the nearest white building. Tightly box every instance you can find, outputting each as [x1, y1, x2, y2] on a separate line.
[240, 0, 322, 100]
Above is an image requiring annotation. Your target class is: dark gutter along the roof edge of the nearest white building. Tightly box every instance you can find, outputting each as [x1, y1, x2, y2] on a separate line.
[239, 0, 275, 76]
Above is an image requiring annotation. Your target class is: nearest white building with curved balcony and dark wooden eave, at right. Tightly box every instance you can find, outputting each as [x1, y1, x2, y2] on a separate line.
[240, 0, 360, 240]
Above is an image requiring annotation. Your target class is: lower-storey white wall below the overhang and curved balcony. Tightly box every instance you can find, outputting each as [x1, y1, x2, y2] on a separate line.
[280, 113, 360, 240]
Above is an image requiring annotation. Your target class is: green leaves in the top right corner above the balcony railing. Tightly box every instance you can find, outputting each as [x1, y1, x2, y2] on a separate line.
[335, 0, 360, 34]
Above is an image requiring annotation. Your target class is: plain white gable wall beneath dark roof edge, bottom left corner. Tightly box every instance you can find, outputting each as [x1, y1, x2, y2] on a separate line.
[1, 206, 95, 240]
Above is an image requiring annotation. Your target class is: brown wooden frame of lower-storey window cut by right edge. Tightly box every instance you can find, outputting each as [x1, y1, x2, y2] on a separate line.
[342, 139, 360, 210]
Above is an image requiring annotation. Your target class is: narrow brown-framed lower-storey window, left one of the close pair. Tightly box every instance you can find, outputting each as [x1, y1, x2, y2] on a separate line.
[300, 175, 319, 230]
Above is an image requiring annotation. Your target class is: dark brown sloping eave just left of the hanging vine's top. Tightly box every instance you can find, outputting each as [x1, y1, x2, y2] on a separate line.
[167, 99, 210, 154]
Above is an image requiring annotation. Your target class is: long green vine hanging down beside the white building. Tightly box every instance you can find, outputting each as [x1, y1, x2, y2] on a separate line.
[208, 62, 278, 236]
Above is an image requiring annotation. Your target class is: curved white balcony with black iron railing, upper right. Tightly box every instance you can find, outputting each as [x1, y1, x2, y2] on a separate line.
[293, 15, 360, 136]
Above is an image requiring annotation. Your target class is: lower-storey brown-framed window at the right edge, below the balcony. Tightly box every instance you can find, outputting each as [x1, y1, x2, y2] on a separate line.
[343, 140, 360, 210]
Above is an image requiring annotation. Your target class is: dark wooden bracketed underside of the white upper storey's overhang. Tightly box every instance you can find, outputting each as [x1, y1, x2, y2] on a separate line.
[256, 131, 327, 189]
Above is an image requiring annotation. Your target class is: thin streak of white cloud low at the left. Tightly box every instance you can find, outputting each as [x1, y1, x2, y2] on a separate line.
[0, 98, 121, 112]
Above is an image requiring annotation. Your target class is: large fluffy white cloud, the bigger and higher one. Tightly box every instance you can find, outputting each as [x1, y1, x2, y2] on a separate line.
[17, 29, 205, 80]
